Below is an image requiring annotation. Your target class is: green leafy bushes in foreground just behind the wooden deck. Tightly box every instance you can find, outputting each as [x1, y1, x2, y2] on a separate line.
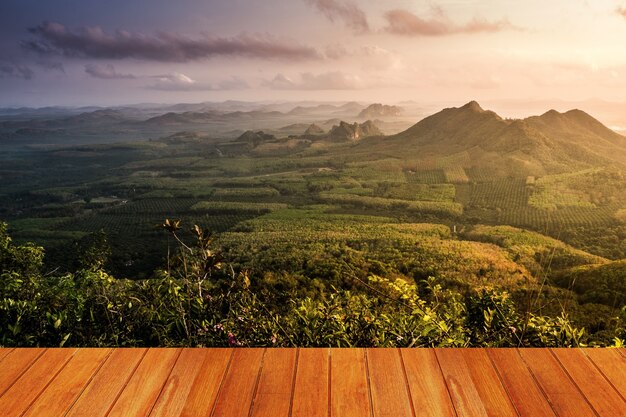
[0, 220, 624, 347]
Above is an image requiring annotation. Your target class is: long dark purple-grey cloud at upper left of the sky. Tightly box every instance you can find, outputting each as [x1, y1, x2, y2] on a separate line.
[22, 22, 321, 62]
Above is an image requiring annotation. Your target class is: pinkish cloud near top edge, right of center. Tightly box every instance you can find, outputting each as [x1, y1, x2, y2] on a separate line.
[384, 8, 515, 36]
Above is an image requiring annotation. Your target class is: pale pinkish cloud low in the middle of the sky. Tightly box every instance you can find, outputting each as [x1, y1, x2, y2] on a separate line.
[263, 71, 363, 90]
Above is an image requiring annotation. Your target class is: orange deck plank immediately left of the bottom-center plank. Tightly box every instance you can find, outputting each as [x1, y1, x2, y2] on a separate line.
[251, 349, 298, 417]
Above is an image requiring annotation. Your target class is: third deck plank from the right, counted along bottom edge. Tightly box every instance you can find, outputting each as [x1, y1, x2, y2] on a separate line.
[487, 349, 556, 417]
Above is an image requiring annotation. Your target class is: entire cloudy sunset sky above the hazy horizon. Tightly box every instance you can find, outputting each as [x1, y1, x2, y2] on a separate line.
[0, 0, 626, 107]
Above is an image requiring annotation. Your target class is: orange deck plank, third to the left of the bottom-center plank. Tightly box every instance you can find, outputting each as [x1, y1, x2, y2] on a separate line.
[180, 349, 233, 417]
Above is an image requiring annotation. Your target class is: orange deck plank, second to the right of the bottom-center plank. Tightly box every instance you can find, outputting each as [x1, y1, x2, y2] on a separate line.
[366, 349, 413, 417]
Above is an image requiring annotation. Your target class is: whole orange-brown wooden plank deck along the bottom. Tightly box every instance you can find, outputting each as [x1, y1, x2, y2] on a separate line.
[0, 348, 626, 417]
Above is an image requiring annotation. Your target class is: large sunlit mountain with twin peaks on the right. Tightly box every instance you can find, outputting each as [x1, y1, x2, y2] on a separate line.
[372, 101, 626, 177]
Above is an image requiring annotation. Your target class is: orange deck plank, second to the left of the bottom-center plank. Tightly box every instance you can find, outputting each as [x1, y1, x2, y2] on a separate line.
[212, 348, 265, 417]
